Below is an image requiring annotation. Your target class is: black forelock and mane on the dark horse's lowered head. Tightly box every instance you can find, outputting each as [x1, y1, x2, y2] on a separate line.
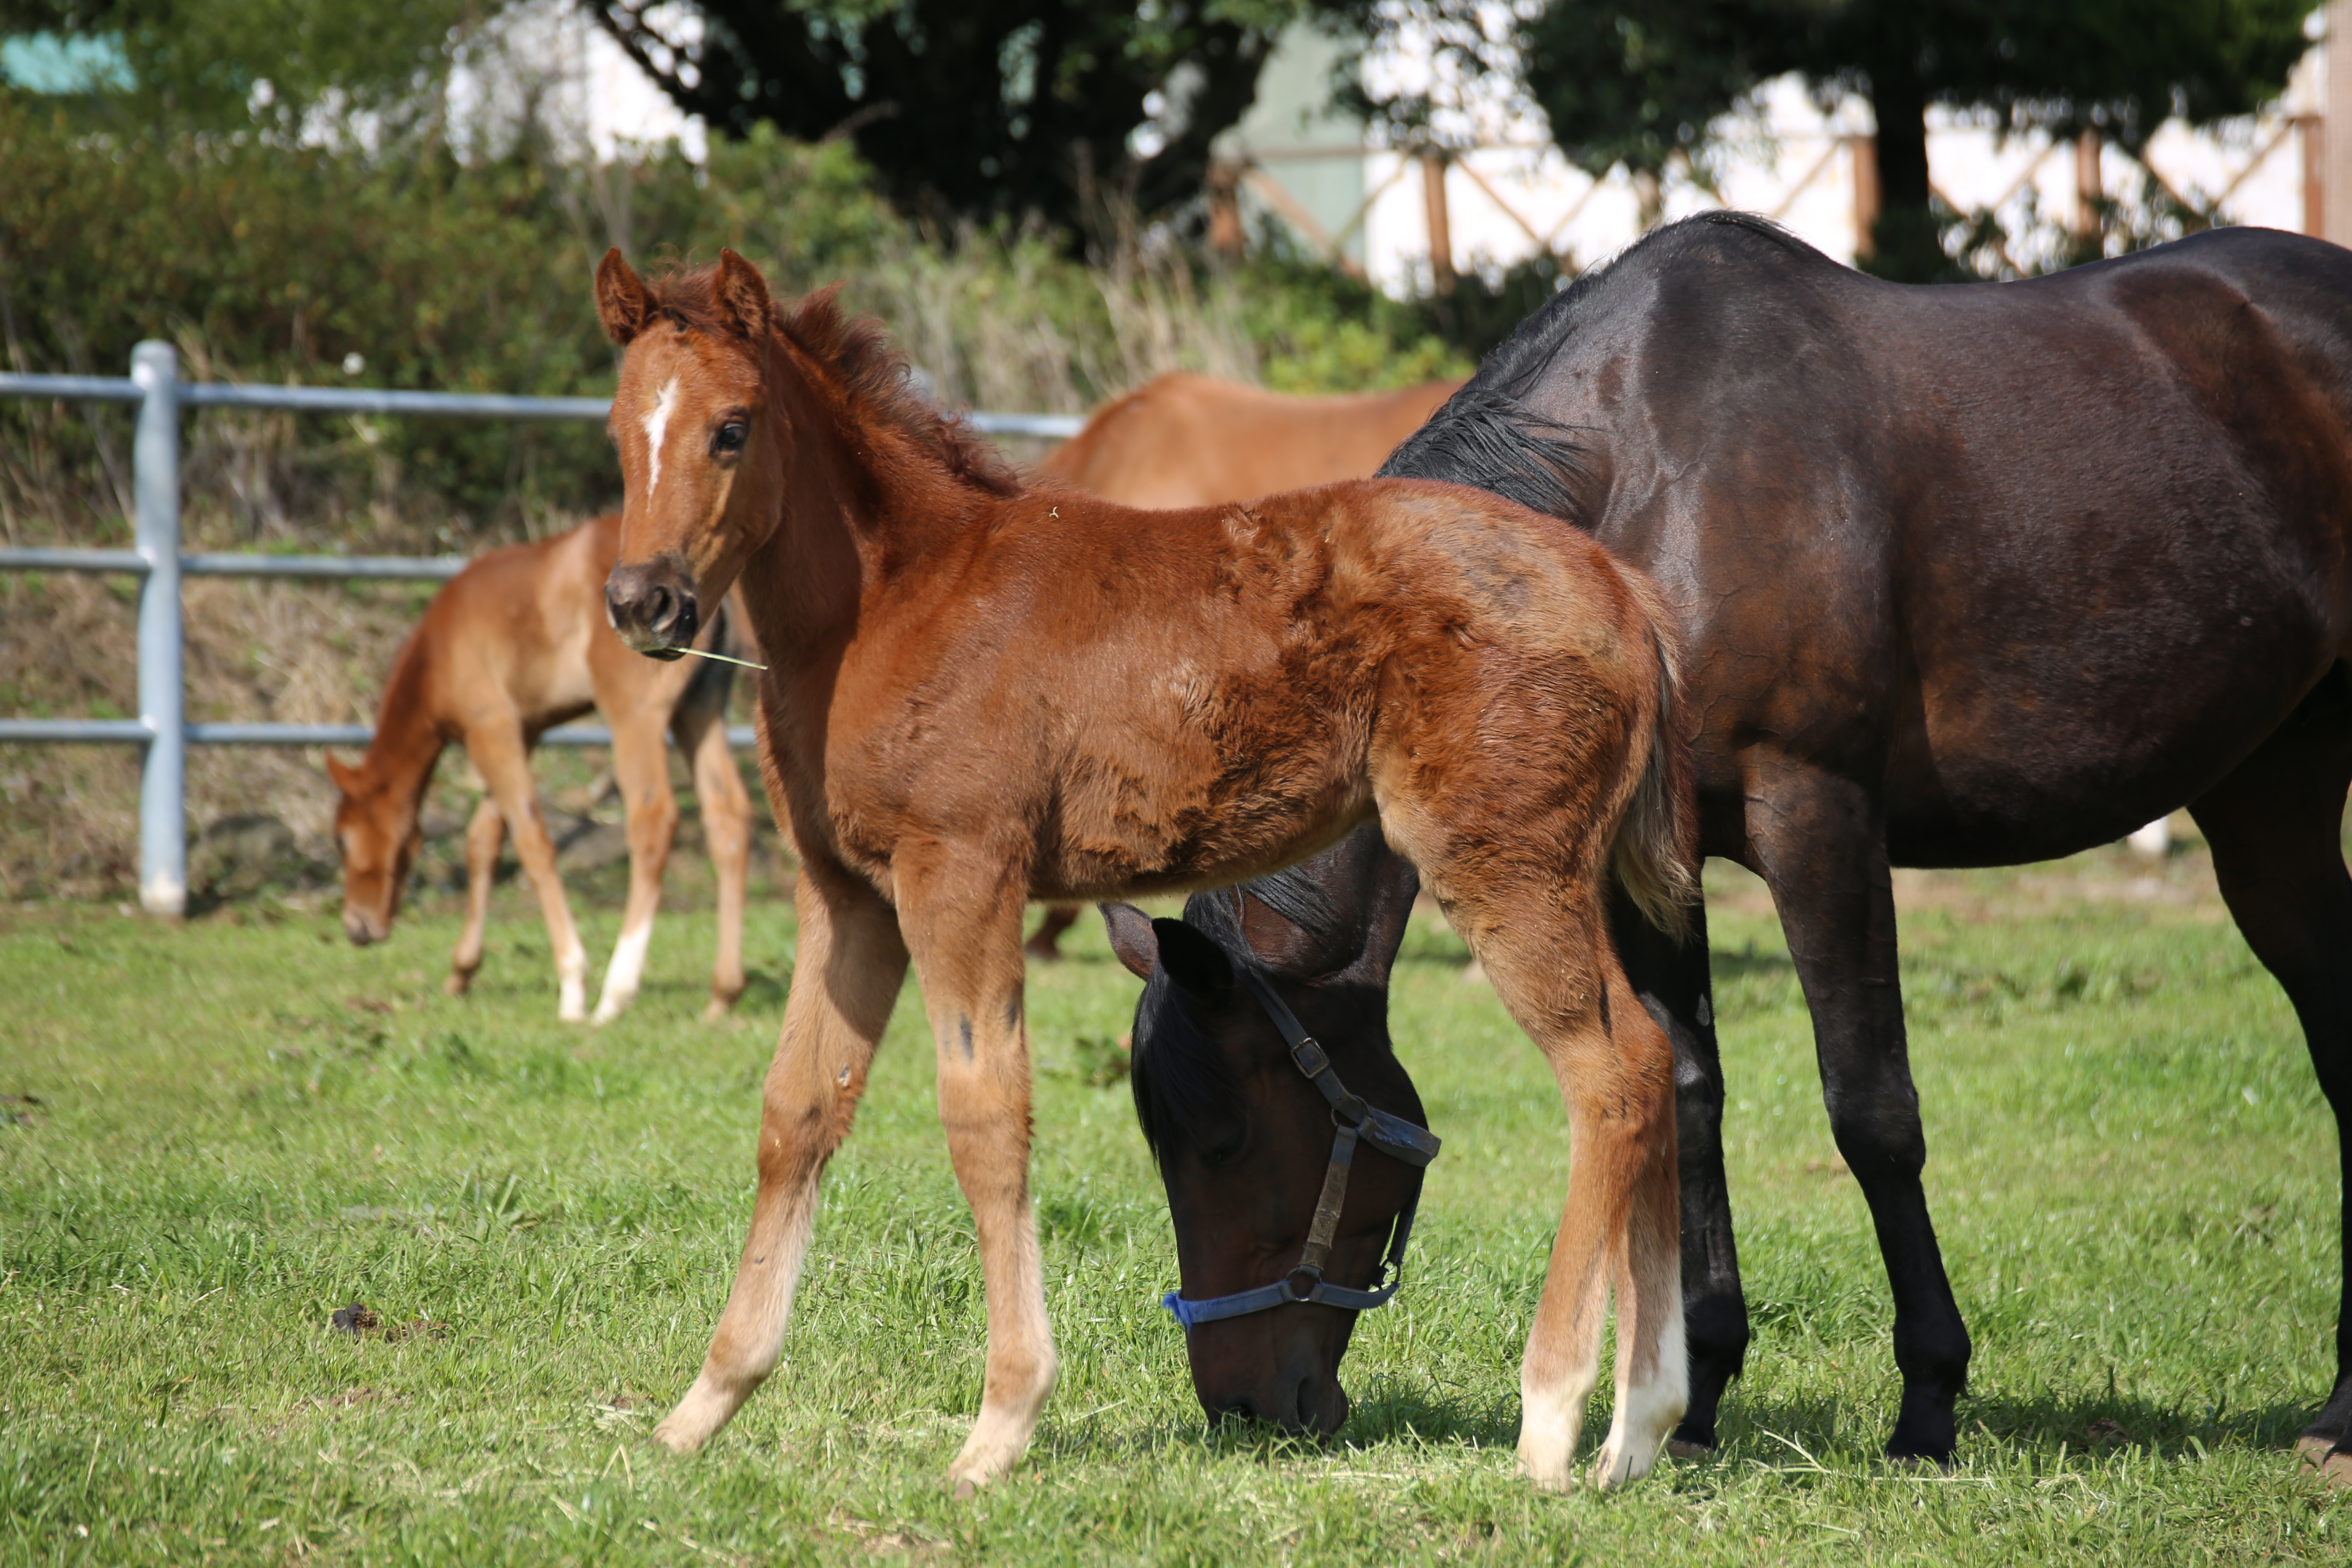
[1129, 860, 1350, 1161]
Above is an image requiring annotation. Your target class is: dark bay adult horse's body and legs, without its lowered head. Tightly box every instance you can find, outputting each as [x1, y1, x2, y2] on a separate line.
[1136, 214, 2352, 1479]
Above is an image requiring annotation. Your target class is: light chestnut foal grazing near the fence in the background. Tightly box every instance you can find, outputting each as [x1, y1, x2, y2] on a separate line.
[327, 517, 750, 1022]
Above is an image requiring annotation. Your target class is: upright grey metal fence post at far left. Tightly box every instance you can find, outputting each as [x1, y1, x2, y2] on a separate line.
[132, 339, 188, 915]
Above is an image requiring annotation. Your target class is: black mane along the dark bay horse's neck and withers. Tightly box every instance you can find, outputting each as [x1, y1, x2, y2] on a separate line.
[1378, 212, 1804, 531]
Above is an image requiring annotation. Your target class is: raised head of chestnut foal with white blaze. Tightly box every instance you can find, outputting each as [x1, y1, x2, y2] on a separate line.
[595, 249, 790, 658]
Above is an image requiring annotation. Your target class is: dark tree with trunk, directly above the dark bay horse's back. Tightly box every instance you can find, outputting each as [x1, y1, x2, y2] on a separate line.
[1357, 0, 2312, 282]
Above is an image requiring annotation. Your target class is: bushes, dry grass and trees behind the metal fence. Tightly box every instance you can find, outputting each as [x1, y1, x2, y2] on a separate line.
[0, 0, 2310, 895]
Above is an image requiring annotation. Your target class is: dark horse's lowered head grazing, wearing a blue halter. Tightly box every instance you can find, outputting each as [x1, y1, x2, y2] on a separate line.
[1103, 828, 1425, 1437]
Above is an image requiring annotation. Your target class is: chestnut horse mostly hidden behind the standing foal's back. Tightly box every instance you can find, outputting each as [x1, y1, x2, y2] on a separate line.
[1028, 372, 1463, 959]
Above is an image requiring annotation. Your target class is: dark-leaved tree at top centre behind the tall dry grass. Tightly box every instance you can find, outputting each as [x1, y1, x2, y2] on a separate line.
[583, 0, 1305, 226]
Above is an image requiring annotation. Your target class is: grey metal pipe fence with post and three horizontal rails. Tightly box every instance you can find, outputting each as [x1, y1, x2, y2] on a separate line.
[0, 341, 1084, 915]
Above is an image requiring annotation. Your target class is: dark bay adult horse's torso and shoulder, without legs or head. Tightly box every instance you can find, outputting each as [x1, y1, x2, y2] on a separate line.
[1505, 226, 2352, 863]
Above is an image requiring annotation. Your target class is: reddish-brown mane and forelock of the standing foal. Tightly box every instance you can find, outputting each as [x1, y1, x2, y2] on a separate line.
[647, 266, 1021, 496]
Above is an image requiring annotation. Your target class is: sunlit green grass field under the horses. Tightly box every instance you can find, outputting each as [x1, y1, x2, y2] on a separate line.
[0, 851, 2352, 1563]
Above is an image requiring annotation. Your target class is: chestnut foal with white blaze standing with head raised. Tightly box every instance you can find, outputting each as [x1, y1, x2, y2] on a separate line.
[597, 252, 1691, 1493]
